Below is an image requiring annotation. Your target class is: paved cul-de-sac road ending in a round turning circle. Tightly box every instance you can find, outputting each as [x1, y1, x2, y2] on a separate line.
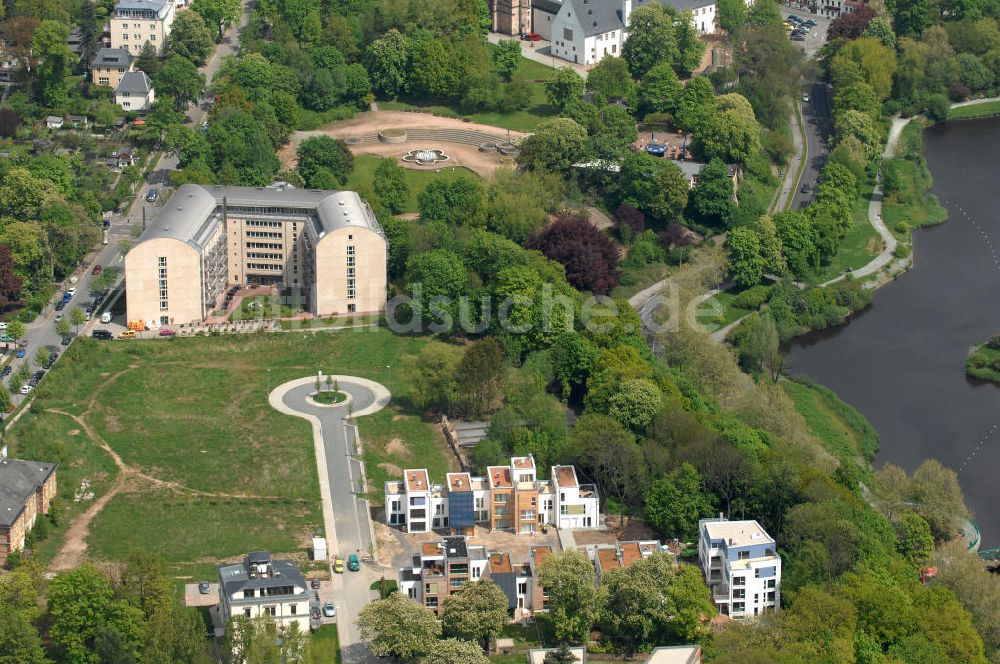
[268, 376, 391, 664]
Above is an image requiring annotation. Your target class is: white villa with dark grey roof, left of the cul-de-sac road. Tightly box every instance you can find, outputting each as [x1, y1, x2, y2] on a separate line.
[219, 551, 310, 634]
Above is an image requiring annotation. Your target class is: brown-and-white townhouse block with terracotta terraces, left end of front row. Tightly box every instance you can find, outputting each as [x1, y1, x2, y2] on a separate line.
[399, 537, 489, 614]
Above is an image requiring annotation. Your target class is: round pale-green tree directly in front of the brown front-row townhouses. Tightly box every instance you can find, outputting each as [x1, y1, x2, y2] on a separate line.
[441, 579, 508, 652]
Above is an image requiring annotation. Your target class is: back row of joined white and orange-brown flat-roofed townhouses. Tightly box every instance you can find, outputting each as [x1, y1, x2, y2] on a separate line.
[386, 456, 600, 534]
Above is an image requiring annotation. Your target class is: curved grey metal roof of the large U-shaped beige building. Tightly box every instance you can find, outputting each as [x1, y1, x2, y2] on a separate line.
[142, 184, 384, 250]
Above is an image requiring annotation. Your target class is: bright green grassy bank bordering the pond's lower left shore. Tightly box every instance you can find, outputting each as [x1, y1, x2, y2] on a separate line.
[781, 379, 878, 468]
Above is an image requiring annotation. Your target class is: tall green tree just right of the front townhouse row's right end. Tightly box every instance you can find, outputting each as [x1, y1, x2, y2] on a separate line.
[538, 550, 602, 643]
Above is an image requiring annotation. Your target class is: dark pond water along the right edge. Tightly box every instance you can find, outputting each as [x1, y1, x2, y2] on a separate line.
[788, 119, 1000, 548]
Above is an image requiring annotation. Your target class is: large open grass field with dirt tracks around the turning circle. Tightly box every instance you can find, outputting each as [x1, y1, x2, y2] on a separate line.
[7, 328, 449, 574]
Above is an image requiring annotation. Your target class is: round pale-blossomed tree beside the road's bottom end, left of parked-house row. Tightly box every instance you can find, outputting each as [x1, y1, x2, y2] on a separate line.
[357, 593, 441, 660]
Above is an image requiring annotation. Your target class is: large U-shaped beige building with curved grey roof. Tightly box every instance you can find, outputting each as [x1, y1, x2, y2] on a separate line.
[125, 184, 388, 327]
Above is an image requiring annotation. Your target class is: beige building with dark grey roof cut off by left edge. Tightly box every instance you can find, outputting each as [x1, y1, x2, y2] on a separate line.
[0, 447, 57, 565]
